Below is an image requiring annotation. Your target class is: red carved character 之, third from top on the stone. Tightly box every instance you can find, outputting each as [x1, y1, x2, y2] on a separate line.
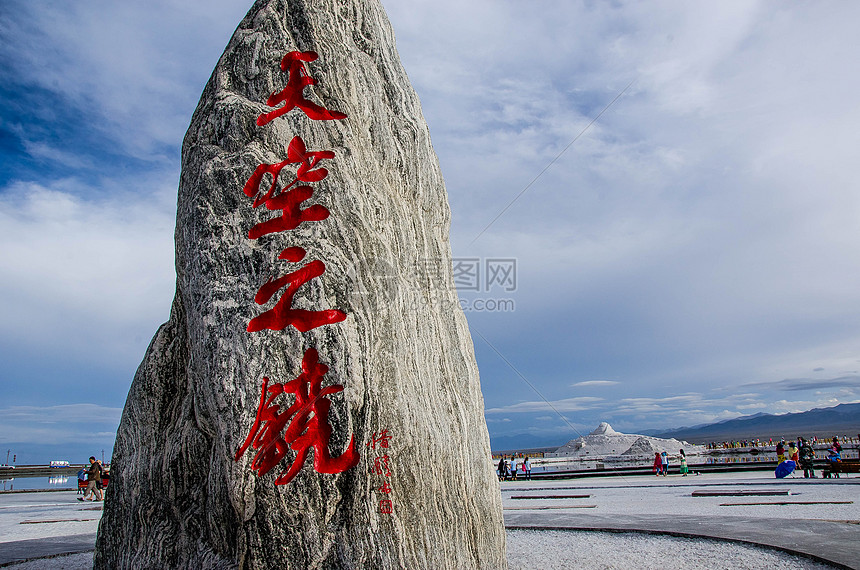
[247, 247, 346, 332]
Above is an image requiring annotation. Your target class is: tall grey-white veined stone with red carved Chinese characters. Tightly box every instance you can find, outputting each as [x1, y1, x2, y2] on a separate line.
[95, 0, 505, 570]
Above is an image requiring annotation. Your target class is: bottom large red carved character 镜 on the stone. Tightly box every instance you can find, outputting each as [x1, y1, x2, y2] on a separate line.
[235, 348, 359, 485]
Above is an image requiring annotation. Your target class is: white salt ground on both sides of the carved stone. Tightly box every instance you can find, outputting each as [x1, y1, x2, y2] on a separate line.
[0, 472, 860, 570]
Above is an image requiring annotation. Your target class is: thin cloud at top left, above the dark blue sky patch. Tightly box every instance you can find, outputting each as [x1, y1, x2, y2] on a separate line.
[2, 0, 249, 157]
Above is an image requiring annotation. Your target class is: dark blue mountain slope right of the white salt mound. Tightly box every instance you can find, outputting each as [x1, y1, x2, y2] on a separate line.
[646, 403, 860, 443]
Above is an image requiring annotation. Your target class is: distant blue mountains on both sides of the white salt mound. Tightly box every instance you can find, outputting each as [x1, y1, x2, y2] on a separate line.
[490, 404, 860, 453]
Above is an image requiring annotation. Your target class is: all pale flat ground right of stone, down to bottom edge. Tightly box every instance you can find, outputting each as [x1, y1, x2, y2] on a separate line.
[500, 471, 860, 570]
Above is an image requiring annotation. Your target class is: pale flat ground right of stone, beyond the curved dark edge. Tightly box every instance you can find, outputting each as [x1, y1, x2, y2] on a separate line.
[501, 472, 860, 570]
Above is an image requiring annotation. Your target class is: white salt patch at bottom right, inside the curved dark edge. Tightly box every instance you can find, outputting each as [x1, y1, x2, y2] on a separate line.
[507, 530, 834, 570]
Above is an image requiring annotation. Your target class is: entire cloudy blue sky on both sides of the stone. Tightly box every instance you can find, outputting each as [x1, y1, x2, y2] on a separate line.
[0, 0, 860, 463]
